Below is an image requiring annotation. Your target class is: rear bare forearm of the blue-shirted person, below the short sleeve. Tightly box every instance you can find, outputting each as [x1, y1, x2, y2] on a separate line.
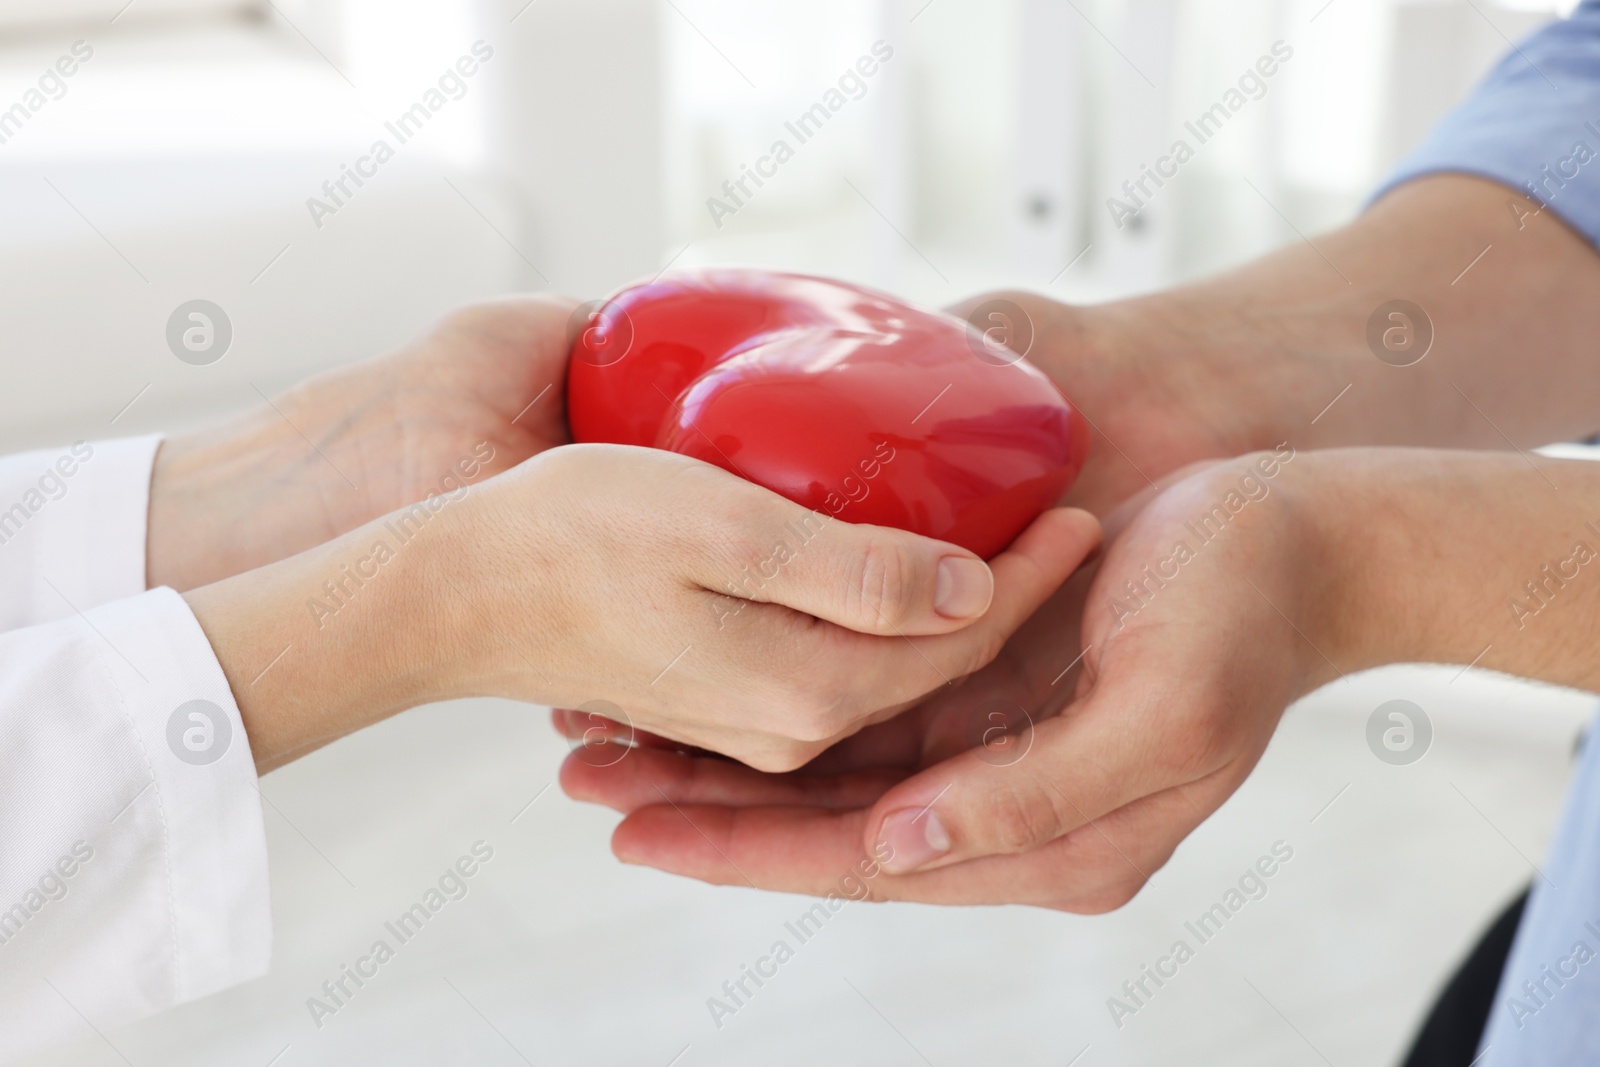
[1062, 176, 1600, 457]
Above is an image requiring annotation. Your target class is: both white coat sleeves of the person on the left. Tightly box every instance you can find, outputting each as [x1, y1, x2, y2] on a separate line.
[0, 438, 272, 1061]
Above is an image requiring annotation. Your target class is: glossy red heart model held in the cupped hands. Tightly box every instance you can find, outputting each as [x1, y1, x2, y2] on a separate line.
[566, 269, 1090, 558]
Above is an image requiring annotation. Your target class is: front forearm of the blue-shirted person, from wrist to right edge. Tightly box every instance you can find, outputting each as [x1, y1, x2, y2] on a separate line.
[1294, 450, 1600, 691]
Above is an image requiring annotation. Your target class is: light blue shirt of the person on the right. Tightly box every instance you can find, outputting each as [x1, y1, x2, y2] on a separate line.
[1378, 0, 1600, 1067]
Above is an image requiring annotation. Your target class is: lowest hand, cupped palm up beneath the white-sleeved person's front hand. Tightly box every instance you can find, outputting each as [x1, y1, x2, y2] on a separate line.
[557, 456, 1339, 912]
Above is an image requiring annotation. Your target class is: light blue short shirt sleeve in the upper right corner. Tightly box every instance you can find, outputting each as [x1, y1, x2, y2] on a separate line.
[1374, 0, 1600, 248]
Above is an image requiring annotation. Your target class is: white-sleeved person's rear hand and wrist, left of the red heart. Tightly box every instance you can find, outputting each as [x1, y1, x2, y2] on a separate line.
[146, 294, 573, 590]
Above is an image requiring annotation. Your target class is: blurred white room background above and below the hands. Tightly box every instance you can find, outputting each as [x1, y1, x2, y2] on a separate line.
[0, 0, 1592, 1067]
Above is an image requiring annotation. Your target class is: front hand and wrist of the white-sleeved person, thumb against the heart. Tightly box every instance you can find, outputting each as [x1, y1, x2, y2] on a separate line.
[178, 445, 1099, 771]
